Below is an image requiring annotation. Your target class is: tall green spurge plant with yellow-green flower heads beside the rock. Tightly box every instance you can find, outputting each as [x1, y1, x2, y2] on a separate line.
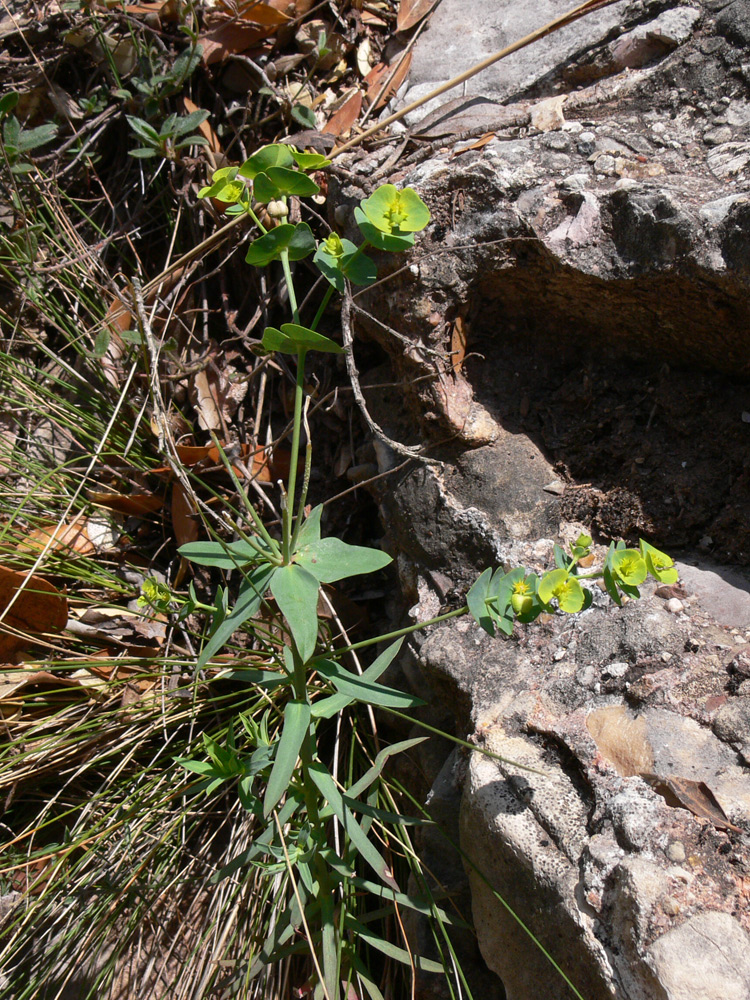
[144, 145, 677, 1000]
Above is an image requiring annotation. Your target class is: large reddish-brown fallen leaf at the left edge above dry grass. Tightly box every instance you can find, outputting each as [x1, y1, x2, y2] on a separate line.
[0, 566, 68, 662]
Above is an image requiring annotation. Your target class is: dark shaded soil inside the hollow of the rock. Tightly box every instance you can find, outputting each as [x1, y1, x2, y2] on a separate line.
[466, 329, 750, 565]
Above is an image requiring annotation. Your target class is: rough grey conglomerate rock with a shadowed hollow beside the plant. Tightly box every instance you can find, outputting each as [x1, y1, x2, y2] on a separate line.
[342, 0, 750, 1000]
